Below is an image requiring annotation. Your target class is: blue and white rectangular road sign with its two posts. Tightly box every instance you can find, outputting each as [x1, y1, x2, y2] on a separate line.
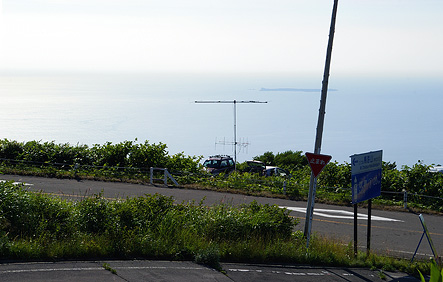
[351, 150, 383, 255]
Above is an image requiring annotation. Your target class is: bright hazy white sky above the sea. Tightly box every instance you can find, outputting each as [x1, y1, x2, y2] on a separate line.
[0, 0, 443, 76]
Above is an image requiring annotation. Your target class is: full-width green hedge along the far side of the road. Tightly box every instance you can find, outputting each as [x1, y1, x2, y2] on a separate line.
[0, 139, 443, 211]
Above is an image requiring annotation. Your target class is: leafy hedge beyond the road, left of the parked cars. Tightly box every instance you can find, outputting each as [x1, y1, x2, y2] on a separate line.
[0, 139, 201, 172]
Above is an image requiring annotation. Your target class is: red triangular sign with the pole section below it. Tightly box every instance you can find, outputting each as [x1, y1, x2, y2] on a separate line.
[305, 153, 332, 248]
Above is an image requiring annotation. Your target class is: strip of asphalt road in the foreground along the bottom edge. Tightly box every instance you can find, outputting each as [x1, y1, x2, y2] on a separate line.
[0, 260, 418, 282]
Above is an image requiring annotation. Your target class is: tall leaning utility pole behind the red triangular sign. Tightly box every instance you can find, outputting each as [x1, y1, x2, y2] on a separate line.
[304, 0, 338, 248]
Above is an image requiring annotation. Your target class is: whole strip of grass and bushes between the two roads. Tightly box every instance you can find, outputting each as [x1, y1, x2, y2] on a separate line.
[0, 182, 430, 274]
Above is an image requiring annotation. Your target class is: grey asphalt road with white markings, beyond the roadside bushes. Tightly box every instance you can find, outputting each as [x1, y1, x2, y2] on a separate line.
[0, 175, 443, 281]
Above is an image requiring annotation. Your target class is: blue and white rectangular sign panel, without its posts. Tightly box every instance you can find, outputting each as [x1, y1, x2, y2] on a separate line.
[351, 150, 383, 204]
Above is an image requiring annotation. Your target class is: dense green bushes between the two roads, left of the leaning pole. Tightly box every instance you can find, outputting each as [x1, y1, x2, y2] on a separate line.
[0, 182, 298, 264]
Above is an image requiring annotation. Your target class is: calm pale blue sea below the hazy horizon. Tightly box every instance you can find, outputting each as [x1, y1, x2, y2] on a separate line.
[0, 71, 443, 168]
